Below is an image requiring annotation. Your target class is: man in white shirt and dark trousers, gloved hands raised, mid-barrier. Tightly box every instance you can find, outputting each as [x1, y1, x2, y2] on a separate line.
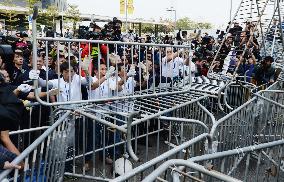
[87, 63, 134, 166]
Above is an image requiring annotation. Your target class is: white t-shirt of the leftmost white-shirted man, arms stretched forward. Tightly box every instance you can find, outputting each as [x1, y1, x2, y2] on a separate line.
[48, 74, 82, 102]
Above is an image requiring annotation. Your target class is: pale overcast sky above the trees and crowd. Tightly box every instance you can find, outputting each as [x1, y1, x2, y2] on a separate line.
[67, 0, 241, 28]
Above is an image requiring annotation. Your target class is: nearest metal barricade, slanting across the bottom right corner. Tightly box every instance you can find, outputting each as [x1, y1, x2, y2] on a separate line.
[143, 140, 284, 182]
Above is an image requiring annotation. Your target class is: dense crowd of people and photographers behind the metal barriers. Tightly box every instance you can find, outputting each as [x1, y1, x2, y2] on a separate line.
[0, 19, 277, 173]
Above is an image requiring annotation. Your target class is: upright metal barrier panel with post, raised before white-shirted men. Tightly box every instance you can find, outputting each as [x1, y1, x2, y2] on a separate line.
[33, 8, 193, 106]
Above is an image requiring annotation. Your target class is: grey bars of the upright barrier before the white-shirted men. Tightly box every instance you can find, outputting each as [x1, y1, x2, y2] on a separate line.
[33, 38, 191, 106]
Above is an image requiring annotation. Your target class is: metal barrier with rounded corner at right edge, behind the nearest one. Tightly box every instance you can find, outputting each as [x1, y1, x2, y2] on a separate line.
[210, 89, 284, 151]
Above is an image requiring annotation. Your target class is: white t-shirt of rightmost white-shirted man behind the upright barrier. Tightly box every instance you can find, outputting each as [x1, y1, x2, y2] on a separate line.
[162, 57, 184, 78]
